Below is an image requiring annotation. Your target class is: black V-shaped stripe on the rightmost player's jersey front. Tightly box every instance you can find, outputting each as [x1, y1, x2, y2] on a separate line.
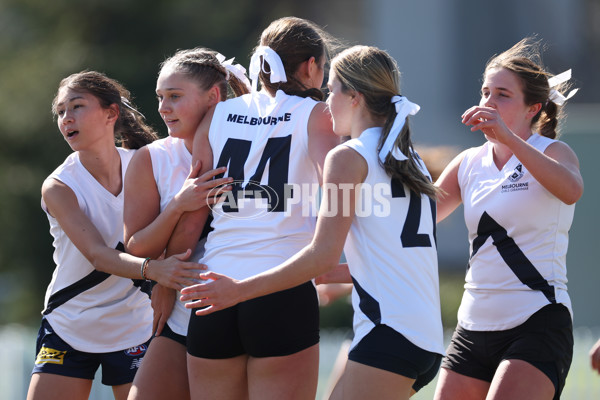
[467, 212, 556, 304]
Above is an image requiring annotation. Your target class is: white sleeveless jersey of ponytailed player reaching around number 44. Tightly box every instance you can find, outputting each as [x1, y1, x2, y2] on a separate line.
[344, 128, 444, 354]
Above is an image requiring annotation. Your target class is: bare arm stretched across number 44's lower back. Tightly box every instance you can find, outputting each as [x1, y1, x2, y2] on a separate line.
[181, 146, 367, 315]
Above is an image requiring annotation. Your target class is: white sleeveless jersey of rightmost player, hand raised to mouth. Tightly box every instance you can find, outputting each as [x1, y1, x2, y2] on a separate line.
[458, 134, 575, 331]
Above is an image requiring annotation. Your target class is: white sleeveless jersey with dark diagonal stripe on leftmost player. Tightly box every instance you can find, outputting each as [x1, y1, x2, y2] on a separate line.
[42, 148, 152, 353]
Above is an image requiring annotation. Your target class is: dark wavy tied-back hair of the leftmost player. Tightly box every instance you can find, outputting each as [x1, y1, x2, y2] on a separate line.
[52, 71, 158, 149]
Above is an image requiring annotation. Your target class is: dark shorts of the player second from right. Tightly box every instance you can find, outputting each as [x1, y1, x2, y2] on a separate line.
[348, 325, 442, 392]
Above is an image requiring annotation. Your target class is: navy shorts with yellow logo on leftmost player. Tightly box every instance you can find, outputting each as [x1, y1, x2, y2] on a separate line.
[32, 318, 149, 386]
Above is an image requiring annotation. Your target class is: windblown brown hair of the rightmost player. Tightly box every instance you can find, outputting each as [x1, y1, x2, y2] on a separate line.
[484, 37, 569, 139]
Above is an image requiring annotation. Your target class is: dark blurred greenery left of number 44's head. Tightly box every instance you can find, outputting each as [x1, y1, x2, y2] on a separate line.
[0, 0, 300, 325]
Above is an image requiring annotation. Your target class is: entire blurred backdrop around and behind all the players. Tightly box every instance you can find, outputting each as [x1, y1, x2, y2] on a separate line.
[0, 0, 600, 327]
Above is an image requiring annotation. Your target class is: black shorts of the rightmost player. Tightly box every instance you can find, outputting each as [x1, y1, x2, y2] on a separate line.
[442, 304, 573, 399]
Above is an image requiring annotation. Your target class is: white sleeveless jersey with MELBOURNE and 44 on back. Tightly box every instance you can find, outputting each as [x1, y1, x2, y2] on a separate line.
[202, 91, 318, 279]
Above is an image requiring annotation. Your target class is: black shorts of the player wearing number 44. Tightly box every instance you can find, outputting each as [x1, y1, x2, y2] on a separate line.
[187, 282, 319, 359]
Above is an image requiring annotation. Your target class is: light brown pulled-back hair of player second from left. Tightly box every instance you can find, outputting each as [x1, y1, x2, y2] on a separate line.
[159, 47, 249, 100]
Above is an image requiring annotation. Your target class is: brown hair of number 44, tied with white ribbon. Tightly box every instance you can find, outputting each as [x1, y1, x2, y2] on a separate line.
[254, 17, 336, 100]
